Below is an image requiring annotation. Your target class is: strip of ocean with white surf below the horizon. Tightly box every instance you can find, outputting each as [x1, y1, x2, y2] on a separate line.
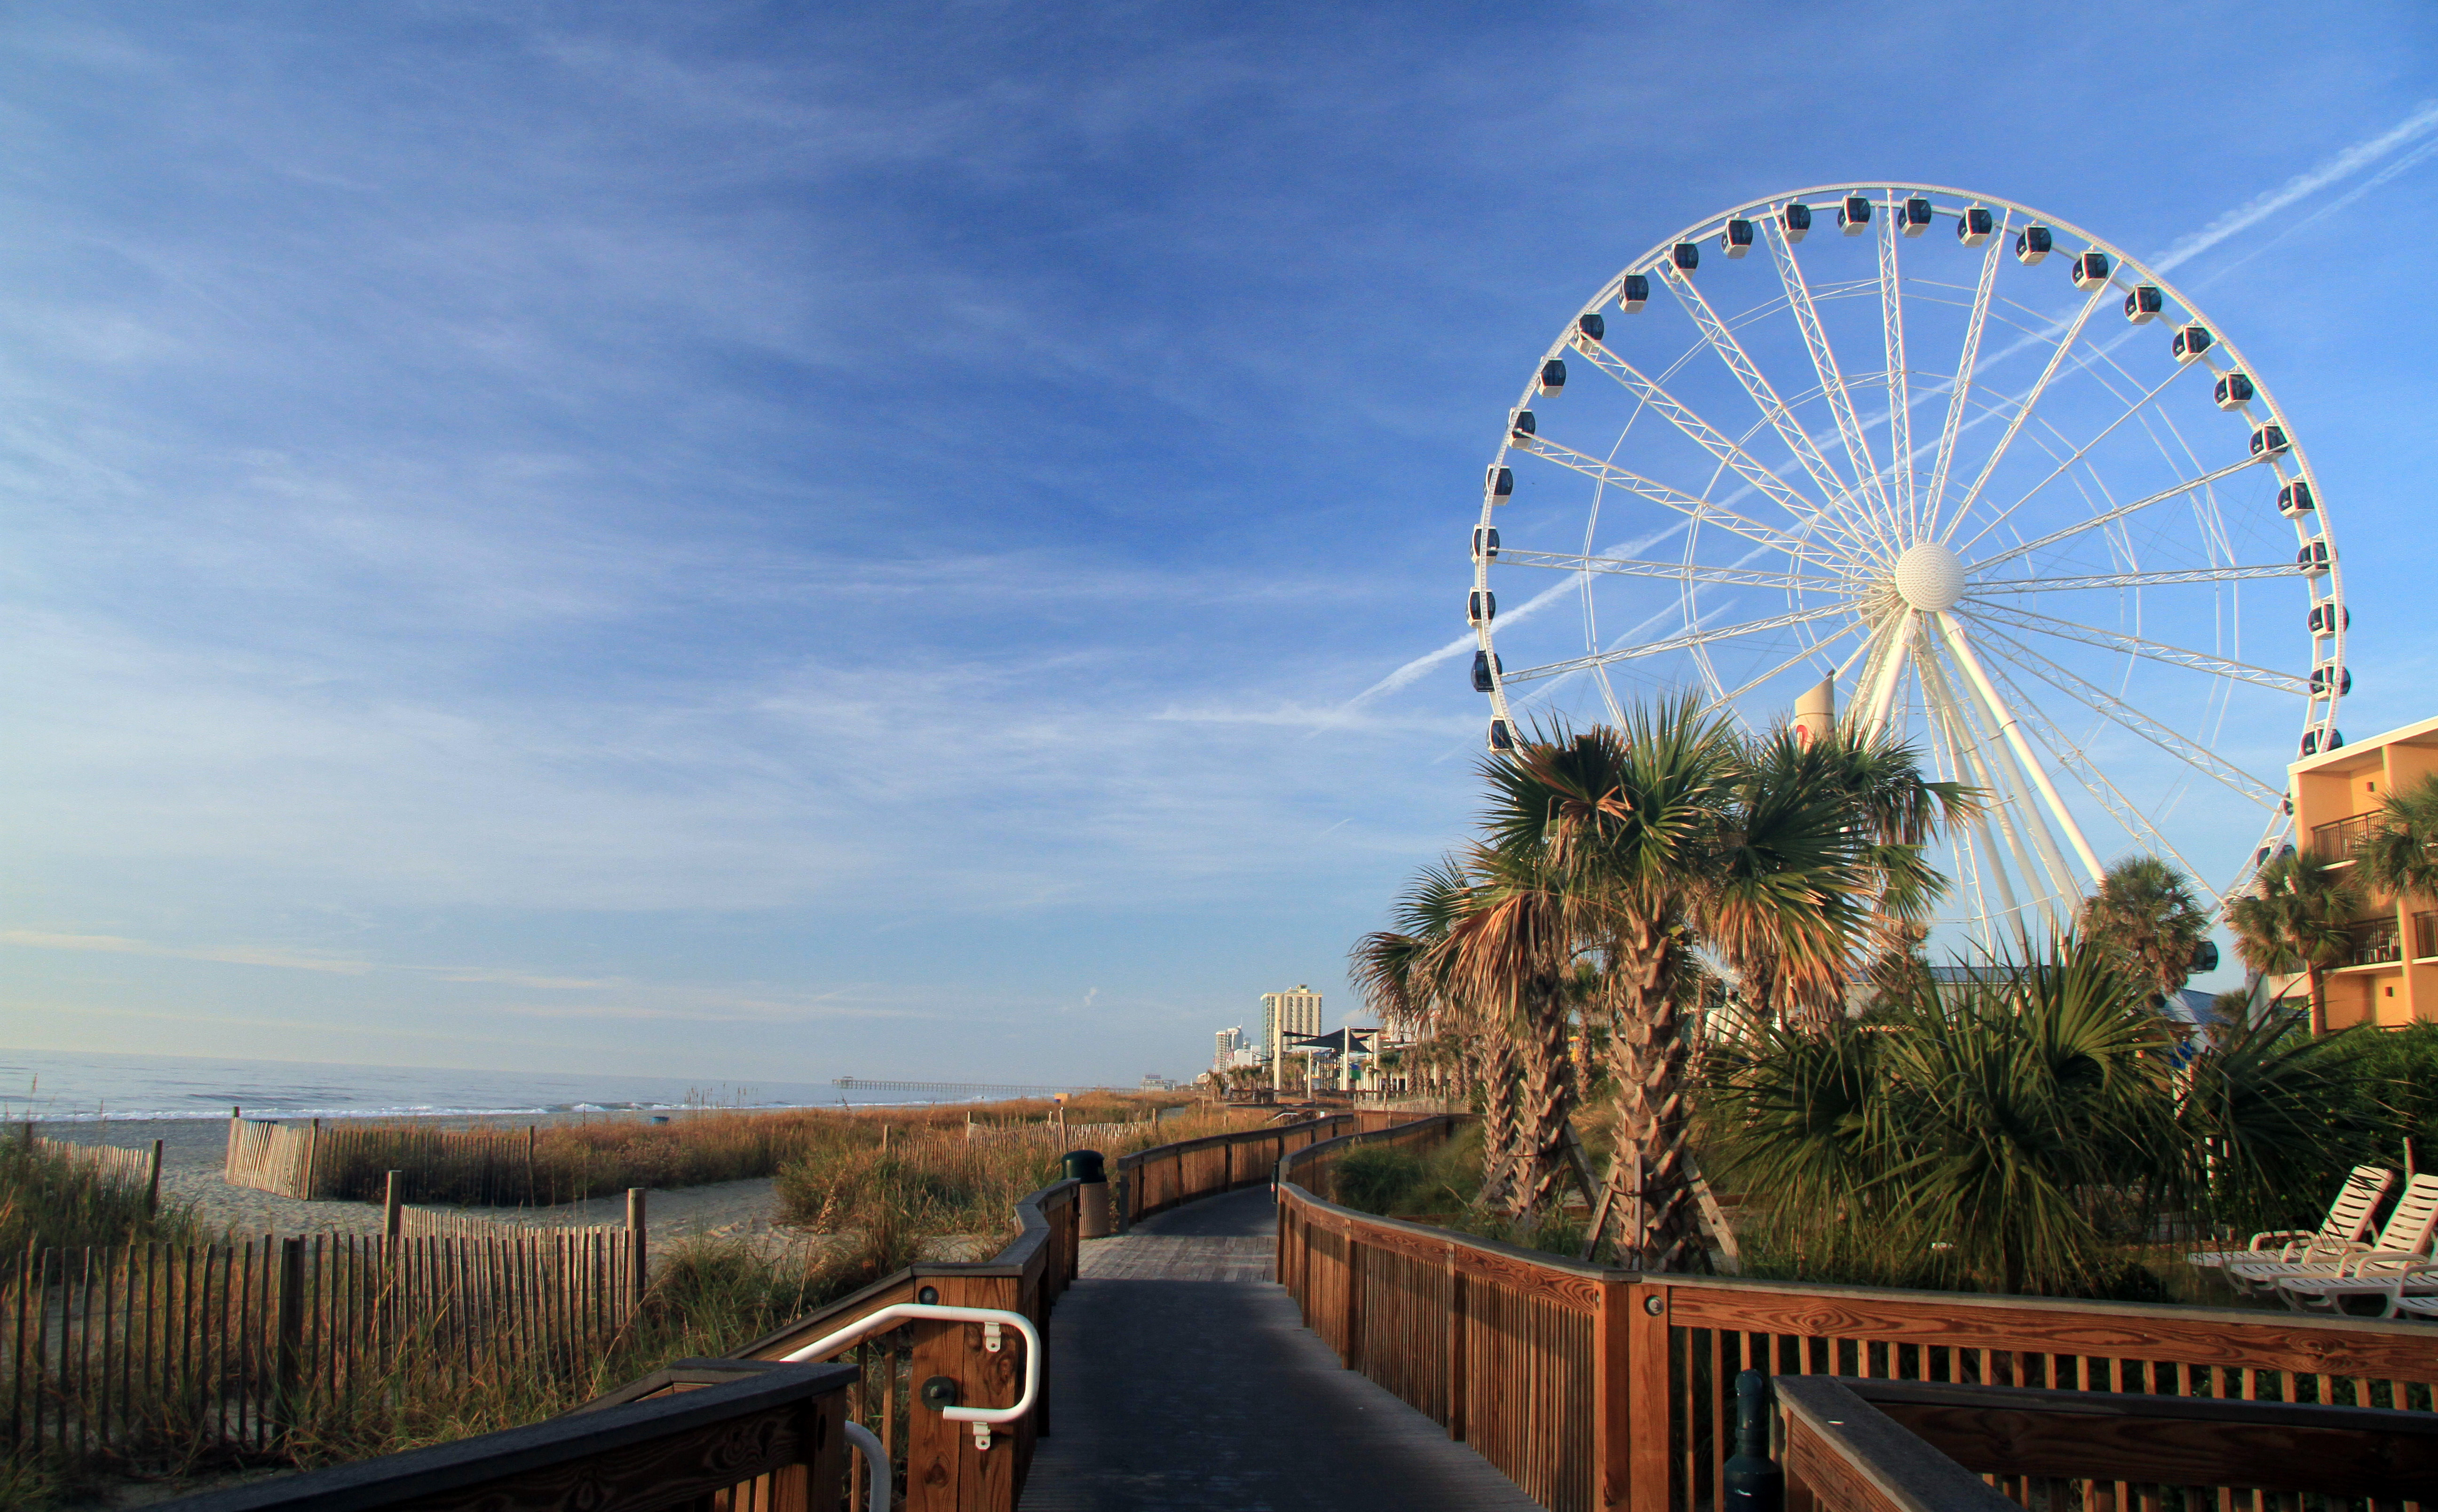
[0, 1048, 907, 1122]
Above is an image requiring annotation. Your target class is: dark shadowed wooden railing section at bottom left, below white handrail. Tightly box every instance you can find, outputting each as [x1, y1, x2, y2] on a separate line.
[157, 1361, 853, 1512]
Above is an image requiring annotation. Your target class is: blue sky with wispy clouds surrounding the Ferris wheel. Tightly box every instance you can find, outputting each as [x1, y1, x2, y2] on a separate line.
[0, 2, 2438, 1080]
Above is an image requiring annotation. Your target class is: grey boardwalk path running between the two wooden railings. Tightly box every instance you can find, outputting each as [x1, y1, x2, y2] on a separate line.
[1024, 1190, 1536, 1512]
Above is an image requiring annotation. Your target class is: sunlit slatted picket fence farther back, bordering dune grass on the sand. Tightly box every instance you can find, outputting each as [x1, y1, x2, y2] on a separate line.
[222, 1117, 546, 1207]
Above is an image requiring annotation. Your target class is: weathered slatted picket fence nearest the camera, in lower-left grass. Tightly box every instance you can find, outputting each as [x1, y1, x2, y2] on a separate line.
[0, 1229, 644, 1461]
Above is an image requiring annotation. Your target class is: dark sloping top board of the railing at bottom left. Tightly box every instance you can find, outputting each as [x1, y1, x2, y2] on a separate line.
[161, 1363, 856, 1512]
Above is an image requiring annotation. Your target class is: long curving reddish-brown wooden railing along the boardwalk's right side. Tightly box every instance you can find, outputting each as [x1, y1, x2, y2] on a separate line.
[1277, 1119, 2438, 1512]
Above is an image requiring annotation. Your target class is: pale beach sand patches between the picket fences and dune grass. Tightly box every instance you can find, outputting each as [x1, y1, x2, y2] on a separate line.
[34, 1112, 839, 1259]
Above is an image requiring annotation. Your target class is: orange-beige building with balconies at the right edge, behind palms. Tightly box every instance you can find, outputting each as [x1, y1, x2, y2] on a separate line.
[2287, 719, 2438, 1029]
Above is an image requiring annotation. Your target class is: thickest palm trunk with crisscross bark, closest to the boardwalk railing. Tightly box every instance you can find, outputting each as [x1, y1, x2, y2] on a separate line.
[1609, 927, 1699, 1270]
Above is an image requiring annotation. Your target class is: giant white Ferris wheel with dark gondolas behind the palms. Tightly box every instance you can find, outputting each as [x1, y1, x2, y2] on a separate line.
[1465, 183, 2353, 949]
